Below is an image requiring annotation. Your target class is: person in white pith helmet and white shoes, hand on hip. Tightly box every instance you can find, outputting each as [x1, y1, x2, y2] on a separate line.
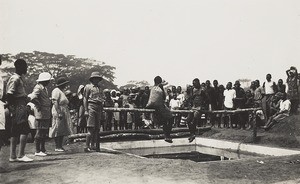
[28, 72, 53, 156]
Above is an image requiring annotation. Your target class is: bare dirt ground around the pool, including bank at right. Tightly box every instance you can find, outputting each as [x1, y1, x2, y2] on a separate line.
[0, 115, 300, 184]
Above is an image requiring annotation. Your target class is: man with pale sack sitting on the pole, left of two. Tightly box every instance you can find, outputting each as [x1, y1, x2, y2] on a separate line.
[146, 76, 173, 143]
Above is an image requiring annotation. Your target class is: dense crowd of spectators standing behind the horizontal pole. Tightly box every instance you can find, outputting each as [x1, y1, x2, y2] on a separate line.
[78, 67, 299, 131]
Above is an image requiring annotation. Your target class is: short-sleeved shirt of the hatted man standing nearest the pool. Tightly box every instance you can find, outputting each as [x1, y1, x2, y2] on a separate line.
[83, 84, 103, 104]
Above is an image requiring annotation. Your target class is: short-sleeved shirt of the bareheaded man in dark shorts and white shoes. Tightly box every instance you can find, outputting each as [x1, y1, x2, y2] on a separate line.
[6, 73, 27, 98]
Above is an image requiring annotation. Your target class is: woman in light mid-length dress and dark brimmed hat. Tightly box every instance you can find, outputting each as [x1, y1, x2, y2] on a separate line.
[49, 77, 71, 152]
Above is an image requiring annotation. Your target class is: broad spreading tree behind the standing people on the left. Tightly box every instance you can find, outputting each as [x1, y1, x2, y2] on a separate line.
[2, 51, 117, 92]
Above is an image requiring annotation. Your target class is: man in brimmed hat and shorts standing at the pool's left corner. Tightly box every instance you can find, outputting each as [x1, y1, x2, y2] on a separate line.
[83, 72, 104, 152]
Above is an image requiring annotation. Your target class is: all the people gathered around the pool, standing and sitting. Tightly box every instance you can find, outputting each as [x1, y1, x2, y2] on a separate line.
[0, 59, 299, 162]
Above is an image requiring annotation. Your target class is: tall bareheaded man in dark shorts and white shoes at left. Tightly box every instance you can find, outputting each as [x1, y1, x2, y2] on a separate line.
[6, 59, 33, 162]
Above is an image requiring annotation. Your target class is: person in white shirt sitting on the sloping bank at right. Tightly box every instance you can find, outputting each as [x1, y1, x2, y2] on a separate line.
[264, 92, 291, 131]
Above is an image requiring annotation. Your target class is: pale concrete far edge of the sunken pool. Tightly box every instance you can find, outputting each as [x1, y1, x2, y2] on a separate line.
[101, 137, 300, 156]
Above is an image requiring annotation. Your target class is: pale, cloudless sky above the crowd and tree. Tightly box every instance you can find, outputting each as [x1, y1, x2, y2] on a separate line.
[0, 0, 300, 86]
